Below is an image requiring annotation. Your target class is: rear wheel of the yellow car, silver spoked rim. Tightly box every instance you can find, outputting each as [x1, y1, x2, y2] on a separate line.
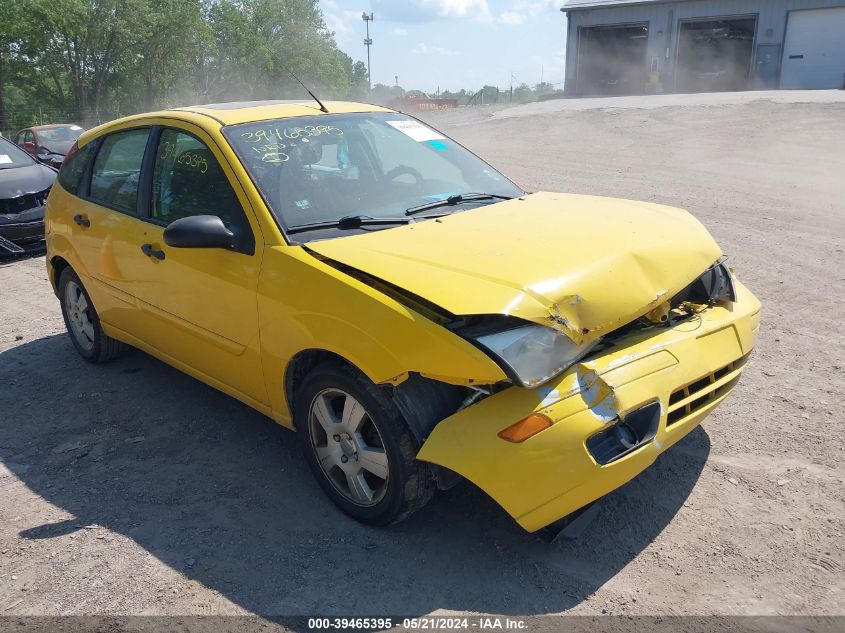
[59, 268, 126, 363]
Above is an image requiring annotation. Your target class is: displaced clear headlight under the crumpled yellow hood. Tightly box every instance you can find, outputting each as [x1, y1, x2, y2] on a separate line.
[472, 320, 598, 388]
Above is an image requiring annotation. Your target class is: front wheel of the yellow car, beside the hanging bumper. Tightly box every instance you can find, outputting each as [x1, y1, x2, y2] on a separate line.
[294, 362, 435, 525]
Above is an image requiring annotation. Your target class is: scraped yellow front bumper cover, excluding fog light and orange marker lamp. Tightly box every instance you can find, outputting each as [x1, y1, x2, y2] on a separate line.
[417, 282, 760, 532]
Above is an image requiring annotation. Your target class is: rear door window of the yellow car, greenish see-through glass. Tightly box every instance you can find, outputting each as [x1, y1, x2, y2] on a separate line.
[89, 129, 150, 214]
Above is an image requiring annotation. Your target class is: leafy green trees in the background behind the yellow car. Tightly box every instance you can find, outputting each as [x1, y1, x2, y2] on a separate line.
[0, 0, 367, 129]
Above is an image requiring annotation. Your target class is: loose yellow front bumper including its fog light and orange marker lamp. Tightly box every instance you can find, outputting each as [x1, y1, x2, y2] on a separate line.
[418, 262, 760, 531]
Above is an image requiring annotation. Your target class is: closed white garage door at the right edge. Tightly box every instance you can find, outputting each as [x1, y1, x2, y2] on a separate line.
[780, 7, 845, 89]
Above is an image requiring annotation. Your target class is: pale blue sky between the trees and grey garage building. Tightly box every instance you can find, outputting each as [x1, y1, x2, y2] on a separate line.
[319, 0, 566, 93]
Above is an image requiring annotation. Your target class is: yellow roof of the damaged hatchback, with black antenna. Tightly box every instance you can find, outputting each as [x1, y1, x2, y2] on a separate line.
[79, 100, 394, 147]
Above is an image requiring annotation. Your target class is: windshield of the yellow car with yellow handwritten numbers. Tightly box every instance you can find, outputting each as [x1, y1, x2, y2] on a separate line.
[223, 113, 522, 241]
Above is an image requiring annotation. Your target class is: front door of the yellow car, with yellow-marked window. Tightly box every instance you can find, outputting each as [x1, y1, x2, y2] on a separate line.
[127, 122, 267, 410]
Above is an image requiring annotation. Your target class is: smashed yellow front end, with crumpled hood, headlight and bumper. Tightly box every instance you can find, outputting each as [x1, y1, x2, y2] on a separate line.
[307, 194, 760, 532]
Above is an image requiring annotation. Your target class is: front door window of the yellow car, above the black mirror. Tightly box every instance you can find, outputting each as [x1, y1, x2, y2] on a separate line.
[152, 129, 249, 232]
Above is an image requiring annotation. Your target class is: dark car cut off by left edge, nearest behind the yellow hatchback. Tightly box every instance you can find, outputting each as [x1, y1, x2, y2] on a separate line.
[0, 137, 56, 257]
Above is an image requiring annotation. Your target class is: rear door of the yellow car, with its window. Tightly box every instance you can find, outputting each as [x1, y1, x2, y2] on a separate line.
[64, 127, 157, 332]
